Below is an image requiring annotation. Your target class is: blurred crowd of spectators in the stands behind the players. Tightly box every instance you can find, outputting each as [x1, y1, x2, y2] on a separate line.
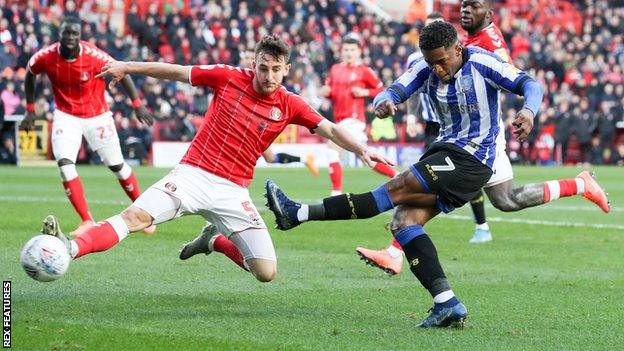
[0, 0, 624, 165]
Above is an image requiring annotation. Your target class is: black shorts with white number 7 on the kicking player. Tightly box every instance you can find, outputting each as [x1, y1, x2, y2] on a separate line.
[410, 142, 492, 213]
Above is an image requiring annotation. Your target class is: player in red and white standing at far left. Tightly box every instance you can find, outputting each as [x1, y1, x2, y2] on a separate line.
[22, 17, 156, 234]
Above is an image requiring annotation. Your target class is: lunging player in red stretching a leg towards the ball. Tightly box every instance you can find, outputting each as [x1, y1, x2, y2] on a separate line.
[36, 36, 387, 282]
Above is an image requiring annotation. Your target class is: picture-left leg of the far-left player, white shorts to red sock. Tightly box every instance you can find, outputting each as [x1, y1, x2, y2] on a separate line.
[52, 111, 93, 226]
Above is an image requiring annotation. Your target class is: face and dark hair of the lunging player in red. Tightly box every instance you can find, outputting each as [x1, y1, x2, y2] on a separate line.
[253, 52, 290, 95]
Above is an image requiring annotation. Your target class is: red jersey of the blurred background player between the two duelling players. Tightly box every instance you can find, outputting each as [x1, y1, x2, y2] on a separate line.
[325, 63, 383, 123]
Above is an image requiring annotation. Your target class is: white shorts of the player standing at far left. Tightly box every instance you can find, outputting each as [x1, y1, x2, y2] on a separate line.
[52, 110, 124, 166]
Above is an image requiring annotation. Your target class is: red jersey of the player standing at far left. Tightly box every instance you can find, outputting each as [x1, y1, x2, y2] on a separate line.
[28, 41, 114, 118]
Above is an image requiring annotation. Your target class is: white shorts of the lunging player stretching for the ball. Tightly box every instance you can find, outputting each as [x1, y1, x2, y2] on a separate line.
[134, 164, 276, 261]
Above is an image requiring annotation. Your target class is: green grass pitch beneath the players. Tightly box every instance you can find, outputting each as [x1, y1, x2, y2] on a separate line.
[0, 166, 624, 350]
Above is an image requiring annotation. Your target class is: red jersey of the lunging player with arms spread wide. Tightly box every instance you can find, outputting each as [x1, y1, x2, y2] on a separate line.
[180, 65, 324, 186]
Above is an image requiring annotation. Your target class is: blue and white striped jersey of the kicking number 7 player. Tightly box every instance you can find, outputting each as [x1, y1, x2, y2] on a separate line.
[388, 47, 531, 168]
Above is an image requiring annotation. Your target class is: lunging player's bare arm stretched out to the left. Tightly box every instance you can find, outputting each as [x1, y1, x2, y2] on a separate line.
[95, 61, 191, 87]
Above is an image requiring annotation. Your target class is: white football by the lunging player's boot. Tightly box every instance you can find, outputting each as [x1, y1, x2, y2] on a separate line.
[20, 235, 71, 282]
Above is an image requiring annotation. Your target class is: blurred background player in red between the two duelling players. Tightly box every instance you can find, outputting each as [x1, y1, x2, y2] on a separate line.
[320, 33, 397, 195]
